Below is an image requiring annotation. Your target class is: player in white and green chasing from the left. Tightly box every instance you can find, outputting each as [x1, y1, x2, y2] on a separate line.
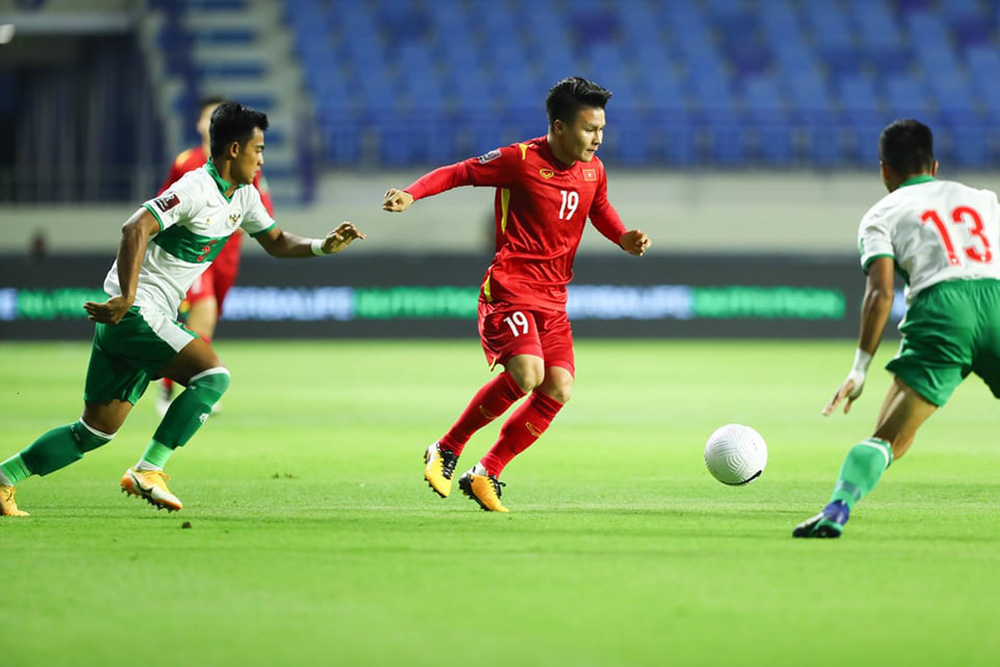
[0, 102, 364, 516]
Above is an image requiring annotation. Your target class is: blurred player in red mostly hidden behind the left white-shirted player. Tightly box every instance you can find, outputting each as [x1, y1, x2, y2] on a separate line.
[156, 97, 274, 417]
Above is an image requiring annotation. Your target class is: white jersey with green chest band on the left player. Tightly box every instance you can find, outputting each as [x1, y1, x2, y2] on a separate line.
[104, 162, 275, 318]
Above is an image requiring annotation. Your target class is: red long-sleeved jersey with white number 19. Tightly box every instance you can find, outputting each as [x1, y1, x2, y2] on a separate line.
[406, 137, 627, 310]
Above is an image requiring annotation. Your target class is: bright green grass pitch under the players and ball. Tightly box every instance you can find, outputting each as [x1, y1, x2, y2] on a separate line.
[0, 340, 1000, 667]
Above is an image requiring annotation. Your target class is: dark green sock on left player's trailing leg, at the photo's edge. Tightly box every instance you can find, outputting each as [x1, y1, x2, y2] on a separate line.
[9, 420, 114, 484]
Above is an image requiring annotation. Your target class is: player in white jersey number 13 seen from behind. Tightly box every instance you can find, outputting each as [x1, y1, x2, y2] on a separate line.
[793, 120, 1000, 537]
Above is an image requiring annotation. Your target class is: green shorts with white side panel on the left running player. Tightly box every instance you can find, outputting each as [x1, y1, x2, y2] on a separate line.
[83, 306, 196, 405]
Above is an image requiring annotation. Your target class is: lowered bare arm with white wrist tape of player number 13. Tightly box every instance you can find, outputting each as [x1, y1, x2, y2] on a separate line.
[823, 256, 895, 416]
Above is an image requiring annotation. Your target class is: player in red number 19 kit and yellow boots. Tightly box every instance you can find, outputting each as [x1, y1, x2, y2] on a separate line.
[382, 77, 649, 512]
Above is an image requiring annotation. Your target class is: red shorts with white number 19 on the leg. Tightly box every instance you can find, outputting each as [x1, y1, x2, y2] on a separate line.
[479, 299, 576, 375]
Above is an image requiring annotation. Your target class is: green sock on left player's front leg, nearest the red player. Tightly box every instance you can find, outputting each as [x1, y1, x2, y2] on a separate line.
[142, 366, 229, 468]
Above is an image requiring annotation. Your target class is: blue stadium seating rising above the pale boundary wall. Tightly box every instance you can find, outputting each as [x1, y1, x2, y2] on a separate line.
[188, 0, 1000, 168]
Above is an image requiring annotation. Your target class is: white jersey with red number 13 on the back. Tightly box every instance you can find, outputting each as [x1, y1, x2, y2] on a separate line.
[858, 176, 1000, 305]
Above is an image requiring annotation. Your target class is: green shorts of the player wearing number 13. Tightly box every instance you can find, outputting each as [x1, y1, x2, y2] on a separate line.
[885, 280, 1000, 407]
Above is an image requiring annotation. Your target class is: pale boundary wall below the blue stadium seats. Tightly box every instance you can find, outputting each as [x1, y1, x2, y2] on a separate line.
[0, 171, 1000, 255]
